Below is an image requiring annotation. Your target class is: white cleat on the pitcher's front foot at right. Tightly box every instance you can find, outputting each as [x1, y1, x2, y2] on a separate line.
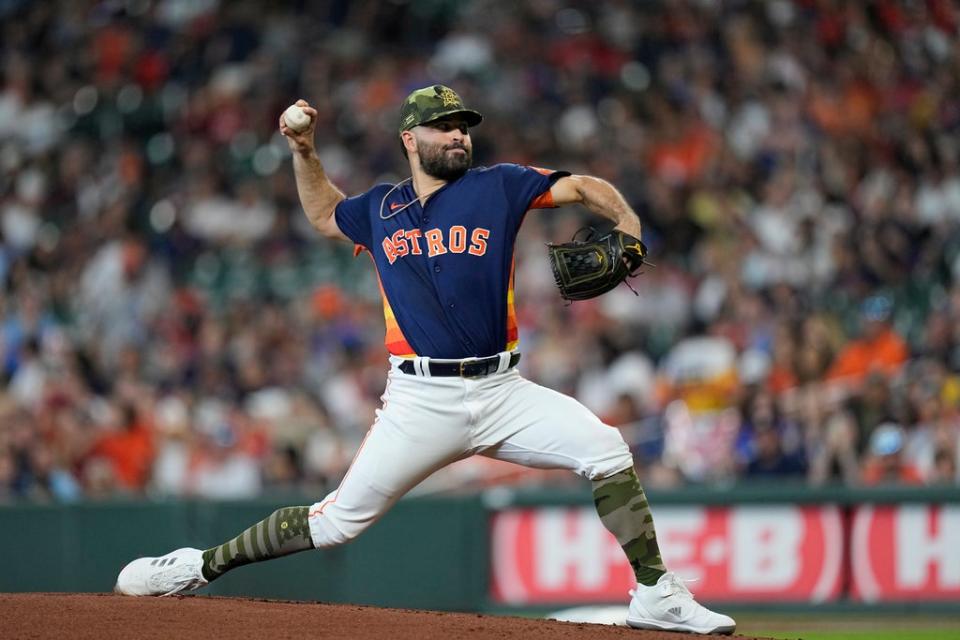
[627, 572, 737, 634]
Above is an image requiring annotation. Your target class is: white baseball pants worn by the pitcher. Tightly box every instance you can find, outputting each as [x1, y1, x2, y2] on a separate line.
[309, 354, 633, 548]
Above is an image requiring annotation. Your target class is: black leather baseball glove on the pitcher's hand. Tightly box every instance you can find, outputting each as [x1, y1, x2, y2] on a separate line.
[547, 229, 647, 300]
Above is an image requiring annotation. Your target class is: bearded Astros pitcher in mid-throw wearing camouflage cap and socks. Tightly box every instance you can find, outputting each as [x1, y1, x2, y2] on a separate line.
[115, 85, 736, 634]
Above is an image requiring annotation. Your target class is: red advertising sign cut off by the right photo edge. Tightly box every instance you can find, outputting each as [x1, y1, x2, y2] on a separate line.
[850, 504, 960, 602]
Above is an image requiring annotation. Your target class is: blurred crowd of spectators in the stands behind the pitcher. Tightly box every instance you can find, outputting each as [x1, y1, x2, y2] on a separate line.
[0, 0, 960, 502]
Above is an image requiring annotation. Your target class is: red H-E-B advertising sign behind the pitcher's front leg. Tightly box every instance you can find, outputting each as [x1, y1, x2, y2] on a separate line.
[491, 505, 843, 605]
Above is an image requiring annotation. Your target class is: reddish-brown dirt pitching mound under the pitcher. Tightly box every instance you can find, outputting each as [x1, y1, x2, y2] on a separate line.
[0, 593, 764, 640]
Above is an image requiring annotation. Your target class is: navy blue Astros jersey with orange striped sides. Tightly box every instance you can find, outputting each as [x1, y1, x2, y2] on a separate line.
[335, 164, 569, 358]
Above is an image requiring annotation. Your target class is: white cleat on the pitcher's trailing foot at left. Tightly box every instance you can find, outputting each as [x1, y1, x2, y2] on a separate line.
[113, 547, 207, 596]
